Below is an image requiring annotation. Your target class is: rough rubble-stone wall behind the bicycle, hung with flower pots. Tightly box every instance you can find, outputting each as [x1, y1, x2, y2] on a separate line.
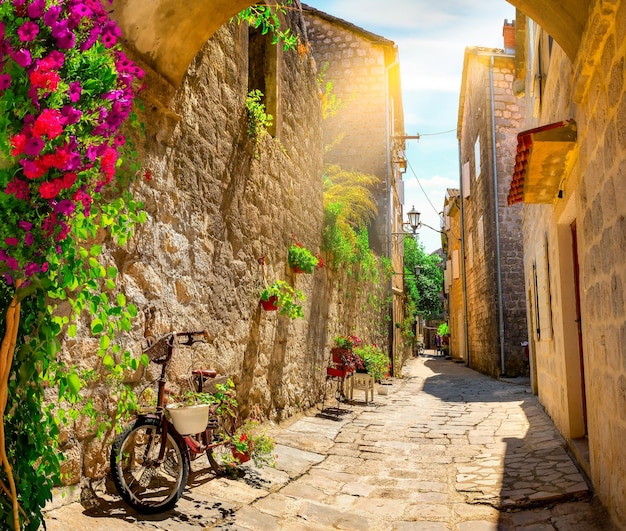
[58, 14, 387, 483]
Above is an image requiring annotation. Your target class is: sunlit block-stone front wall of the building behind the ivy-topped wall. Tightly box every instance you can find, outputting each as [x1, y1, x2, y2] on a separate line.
[305, 10, 393, 254]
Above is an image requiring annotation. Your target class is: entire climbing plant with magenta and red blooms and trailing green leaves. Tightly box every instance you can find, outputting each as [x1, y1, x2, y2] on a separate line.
[0, 0, 147, 529]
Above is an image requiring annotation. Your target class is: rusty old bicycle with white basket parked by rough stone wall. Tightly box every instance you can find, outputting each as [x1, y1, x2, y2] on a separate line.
[110, 331, 232, 514]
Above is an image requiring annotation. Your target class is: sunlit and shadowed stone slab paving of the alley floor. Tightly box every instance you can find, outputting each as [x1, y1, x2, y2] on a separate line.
[46, 355, 614, 531]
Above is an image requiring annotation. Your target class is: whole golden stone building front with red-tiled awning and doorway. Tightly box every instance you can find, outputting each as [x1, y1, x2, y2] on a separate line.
[509, 5, 626, 529]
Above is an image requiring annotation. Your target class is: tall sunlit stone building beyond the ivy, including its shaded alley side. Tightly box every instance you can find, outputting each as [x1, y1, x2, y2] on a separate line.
[304, 7, 410, 374]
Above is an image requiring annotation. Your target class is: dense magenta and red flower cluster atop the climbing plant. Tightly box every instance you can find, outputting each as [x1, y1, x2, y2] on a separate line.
[0, 0, 143, 280]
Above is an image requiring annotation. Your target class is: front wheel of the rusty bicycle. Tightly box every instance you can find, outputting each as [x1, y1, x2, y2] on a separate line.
[111, 417, 189, 514]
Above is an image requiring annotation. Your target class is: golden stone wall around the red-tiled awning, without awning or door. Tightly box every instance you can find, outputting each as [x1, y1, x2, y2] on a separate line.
[524, 0, 626, 528]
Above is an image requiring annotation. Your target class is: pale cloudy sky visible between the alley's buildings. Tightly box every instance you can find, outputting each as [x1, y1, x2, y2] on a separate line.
[306, 0, 515, 252]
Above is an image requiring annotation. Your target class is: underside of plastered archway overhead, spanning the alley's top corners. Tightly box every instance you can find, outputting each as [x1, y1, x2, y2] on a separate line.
[113, 0, 588, 87]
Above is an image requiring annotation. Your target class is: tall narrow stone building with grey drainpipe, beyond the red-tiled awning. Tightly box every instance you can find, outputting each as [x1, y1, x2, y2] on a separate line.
[450, 44, 526, 376]
